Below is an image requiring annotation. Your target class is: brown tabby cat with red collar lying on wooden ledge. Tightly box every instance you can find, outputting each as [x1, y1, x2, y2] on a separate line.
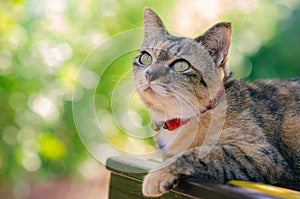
[133, 8, 300, 197]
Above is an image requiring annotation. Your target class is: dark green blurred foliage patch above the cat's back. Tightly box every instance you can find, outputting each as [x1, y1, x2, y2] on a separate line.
[248, 9, 300, 80]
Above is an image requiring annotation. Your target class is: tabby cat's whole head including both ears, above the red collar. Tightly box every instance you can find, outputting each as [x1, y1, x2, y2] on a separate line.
[133, 8, 231, 120]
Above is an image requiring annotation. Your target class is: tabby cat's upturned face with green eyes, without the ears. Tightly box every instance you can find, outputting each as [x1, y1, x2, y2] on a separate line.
[134, 36, 212, 119]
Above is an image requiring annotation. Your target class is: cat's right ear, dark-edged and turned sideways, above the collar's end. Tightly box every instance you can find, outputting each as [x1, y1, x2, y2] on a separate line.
[195, 22, 231, 76]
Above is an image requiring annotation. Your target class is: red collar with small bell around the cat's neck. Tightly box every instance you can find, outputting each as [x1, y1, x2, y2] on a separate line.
[152, 86, 225, 131]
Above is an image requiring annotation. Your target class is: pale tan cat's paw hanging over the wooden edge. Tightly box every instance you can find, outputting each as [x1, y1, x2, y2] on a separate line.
[143, 170, 178, 197]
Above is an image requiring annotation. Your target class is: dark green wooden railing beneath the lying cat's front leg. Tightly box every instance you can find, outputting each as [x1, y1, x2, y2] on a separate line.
[107, 157, 300, 199]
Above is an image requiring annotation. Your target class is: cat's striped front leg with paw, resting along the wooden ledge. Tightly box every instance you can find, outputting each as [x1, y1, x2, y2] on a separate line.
[143, 144, 293, 197]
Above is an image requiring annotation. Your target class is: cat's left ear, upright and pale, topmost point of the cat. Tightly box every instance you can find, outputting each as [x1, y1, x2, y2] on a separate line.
[144, 8, 167, 39]
